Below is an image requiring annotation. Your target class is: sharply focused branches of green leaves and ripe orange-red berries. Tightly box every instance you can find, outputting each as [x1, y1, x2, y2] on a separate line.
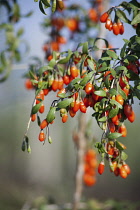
[22, 1, 140, 178]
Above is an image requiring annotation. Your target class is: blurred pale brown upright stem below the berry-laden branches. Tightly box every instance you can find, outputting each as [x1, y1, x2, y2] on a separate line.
[73, 113, 86, 210]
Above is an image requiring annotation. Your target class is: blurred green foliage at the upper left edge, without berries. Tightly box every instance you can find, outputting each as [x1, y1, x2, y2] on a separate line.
[0, 0, 32, 82]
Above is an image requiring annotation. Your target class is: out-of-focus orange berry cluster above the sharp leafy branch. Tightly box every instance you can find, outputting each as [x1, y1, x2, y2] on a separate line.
[42, 0, 103, 61]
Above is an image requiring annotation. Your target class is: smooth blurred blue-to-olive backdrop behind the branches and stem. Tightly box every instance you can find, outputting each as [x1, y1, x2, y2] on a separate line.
[0, 0, 140, 210]
